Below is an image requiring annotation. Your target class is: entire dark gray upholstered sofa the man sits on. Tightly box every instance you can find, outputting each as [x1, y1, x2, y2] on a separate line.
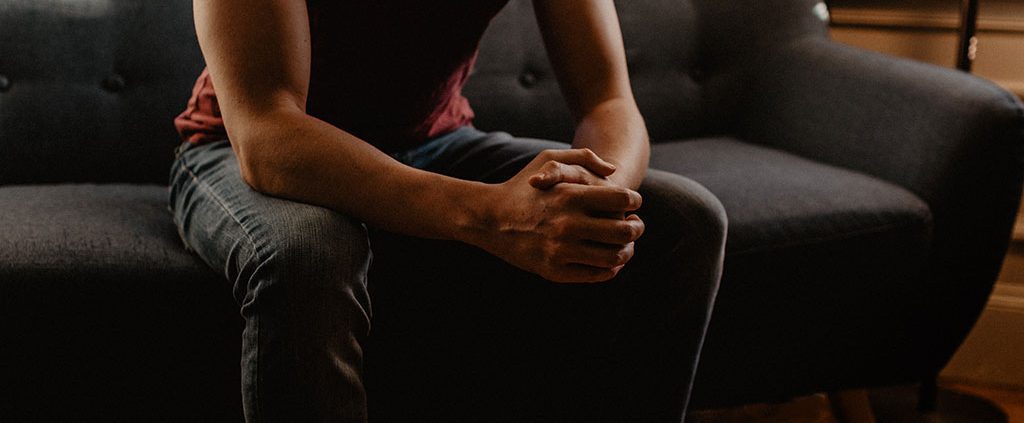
[0, 0, 1024, 421]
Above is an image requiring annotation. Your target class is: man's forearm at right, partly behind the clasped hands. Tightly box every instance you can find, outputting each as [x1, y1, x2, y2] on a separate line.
[572, 98, 650, 189]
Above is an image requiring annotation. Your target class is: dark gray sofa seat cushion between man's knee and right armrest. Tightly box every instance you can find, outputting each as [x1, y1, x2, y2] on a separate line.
[651, 138, 931, 254]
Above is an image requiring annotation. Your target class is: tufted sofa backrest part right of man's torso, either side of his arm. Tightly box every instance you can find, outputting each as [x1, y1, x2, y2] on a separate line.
[464, 0, 827, 142]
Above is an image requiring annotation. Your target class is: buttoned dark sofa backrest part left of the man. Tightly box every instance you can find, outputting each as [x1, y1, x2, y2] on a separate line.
[0, 0, 203, 184]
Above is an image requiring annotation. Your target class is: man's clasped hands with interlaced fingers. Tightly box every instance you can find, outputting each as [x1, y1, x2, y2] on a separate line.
[471, 149, 644, 283]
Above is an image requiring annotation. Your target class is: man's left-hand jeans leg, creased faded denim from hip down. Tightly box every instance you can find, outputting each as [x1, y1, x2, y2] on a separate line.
[171, 141, 370, 422]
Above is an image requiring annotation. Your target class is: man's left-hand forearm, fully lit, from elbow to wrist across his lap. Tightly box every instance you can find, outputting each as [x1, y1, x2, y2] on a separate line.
[231, 113, 487, 241]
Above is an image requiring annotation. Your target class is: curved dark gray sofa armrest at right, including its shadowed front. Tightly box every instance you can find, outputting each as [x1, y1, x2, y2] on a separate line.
[737, 38, 1024, 369]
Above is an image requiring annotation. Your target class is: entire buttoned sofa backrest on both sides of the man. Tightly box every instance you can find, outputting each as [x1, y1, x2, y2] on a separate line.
[0, 0, 825, 184]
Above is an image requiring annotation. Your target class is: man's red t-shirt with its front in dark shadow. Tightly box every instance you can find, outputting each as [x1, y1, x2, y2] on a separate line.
[174, 0, 508, 151]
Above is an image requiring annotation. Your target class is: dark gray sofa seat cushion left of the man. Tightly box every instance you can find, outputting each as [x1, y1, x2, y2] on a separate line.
[0, 184, 211, 274]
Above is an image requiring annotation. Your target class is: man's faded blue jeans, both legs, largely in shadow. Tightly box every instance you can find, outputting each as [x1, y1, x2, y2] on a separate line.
[170, 127, 726, 422]
